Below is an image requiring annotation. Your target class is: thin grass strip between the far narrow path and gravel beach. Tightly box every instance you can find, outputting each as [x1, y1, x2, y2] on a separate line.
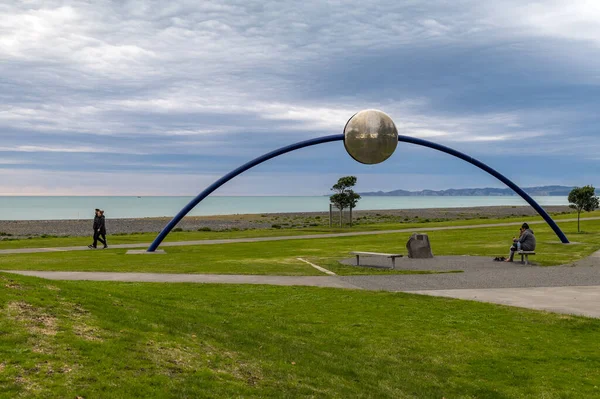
[0, 211, 600, 249]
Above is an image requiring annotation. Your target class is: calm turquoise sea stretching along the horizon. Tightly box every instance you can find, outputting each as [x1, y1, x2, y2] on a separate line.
[0, 196, 568, 220]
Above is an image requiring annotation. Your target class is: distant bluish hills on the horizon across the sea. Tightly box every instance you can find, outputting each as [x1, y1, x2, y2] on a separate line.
[359, 186, 573, 197]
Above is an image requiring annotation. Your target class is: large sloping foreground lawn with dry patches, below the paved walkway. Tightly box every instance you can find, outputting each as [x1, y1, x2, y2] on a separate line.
[0, 274, 600, 399]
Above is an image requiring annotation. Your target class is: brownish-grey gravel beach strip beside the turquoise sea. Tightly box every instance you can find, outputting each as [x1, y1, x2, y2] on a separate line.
[0, 205, 572, 239]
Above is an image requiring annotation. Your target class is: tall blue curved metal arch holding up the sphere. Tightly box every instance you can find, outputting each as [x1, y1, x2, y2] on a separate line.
[147, 134, 569, 252]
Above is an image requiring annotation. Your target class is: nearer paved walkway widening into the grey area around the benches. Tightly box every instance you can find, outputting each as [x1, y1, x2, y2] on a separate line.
[5, 251, 600, 318]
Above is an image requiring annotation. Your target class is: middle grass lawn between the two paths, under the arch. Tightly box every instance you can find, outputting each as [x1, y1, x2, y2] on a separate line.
[0, 220, 600, 275]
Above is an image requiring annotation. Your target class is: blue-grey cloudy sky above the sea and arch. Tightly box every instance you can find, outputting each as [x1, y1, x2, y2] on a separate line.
[0, 0, 600, 195]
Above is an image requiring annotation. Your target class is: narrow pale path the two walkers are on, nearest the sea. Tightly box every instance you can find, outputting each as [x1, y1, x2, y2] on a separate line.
[0, 217, 600, 255]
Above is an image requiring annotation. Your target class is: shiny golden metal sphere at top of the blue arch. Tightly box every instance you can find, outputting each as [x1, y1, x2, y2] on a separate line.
[344, 109, 398, 165]
